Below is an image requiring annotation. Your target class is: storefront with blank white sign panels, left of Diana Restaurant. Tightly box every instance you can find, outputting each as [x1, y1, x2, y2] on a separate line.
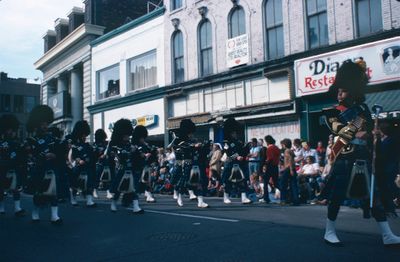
[167, 67, 300, 142]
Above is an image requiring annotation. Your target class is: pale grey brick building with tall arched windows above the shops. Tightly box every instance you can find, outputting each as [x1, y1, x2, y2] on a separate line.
[164, 0, 400, 145]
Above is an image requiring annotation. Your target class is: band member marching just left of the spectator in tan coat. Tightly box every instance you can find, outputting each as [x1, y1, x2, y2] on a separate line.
[169, 119, 208, 208]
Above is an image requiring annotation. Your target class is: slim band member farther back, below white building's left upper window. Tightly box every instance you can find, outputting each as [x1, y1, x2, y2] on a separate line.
[93, 129, 112, 199]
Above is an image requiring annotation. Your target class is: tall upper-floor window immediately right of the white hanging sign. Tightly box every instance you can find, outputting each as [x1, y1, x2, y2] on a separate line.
[264, 0, 285, 59]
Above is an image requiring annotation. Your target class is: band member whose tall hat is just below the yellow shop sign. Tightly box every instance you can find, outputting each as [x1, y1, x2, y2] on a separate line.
[132, 125, 158, 203]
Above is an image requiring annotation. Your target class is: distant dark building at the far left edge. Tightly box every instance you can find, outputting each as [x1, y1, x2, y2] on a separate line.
[0, 72, 40, 138]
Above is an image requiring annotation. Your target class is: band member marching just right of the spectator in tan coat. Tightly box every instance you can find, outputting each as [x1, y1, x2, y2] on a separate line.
[222, 118, 251, 204]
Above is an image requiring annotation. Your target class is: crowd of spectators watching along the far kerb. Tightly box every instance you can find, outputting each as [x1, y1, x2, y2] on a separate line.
[136, 135, 400, 208]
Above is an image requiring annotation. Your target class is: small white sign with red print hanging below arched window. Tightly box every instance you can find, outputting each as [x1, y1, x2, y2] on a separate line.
[226, 34, 249, 68]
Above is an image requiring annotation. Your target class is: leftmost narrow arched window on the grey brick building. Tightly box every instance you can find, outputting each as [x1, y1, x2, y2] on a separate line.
[172, 31, 185, 83]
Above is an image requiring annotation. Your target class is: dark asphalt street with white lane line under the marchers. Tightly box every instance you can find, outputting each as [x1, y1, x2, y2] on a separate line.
[0, 193, 400, 262]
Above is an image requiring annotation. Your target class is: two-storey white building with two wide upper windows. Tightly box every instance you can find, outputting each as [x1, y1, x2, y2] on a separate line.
[88, 8, 165, 145]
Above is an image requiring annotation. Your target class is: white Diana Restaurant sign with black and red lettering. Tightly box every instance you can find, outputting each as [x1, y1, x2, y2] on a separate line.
[294, 37, 400, 97]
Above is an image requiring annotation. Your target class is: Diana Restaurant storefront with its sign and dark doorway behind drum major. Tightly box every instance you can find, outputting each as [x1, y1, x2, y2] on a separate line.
[295, 37, 400, 144]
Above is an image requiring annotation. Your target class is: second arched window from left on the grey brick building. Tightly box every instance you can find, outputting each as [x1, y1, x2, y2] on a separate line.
[198, 20, 213, 76]
